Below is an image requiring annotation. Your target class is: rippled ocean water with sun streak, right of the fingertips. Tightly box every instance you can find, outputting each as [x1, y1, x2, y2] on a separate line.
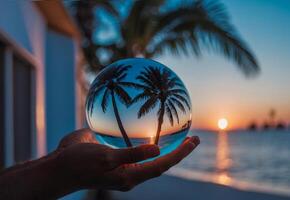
[169, 130, 290, 197]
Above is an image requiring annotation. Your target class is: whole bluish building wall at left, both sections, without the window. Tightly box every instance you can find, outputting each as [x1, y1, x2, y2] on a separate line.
[0, 0, 83, 200]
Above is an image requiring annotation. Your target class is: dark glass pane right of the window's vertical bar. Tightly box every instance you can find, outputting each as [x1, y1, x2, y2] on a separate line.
[13, 58, 33, 162]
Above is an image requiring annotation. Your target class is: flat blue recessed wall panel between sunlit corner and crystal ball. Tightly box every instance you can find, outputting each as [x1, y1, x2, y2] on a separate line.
[45, 31, 77, 152]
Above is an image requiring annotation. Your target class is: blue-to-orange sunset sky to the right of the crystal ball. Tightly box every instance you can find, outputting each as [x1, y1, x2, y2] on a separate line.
[156, 0, 290, 129]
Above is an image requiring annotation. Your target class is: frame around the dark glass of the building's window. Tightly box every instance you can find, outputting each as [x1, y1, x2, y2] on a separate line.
[0, 31, 40, 167]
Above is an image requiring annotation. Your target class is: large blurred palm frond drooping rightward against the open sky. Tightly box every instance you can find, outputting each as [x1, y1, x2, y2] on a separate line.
[149, 1, 259, 75]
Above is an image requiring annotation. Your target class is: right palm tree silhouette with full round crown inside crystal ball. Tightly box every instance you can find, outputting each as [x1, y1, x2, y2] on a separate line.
[132, 66, 190, 144]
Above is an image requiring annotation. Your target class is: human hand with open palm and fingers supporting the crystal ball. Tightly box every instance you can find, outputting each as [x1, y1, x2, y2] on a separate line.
[58, 129, 200, 191]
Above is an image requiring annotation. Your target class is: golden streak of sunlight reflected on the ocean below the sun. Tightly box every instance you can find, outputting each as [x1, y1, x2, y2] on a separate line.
[216, 132, 232, 185]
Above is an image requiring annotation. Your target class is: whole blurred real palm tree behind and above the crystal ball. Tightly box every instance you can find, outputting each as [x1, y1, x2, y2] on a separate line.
[71, 0, 259, 75]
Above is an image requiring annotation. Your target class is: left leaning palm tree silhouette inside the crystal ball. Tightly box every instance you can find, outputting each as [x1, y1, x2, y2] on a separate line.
[87, 65, 134, 147]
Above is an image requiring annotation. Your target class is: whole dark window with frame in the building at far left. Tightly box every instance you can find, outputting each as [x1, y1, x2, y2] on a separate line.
[0, 42, 36, 166]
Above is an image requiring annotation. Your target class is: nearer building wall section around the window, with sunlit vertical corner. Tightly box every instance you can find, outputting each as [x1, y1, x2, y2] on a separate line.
[0, 0, 46, 157]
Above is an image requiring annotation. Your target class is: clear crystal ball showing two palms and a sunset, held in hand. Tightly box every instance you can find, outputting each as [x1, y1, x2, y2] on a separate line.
[86, 58, 191, 155]
